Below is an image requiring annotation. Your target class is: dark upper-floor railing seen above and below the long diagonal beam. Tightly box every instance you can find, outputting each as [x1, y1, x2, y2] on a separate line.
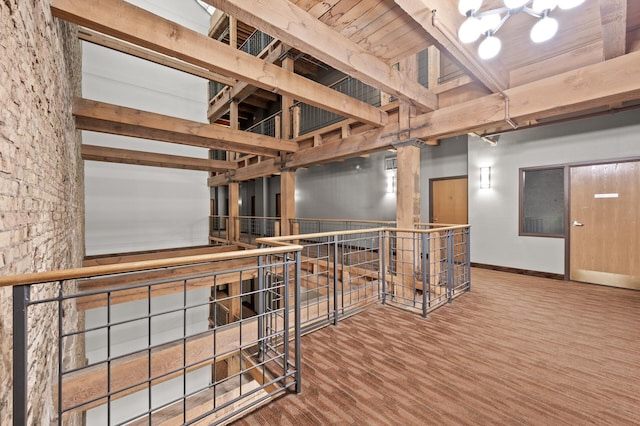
[291, 76, 380, 135]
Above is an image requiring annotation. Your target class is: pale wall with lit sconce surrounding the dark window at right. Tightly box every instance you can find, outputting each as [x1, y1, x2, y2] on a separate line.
[468, 110, 640, 274]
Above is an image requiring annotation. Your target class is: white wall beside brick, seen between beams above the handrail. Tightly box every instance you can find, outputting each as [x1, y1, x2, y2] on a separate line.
[82, 0, 209, 255]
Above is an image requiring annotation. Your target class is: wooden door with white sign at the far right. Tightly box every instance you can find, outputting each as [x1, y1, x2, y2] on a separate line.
[569, 162, 640, 289]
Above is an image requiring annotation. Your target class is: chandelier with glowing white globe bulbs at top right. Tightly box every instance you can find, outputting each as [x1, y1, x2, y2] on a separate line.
[458, 0, 584, 59]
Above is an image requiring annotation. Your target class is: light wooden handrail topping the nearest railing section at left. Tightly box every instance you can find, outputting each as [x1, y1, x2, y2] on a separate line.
[0, 242, 302, 287]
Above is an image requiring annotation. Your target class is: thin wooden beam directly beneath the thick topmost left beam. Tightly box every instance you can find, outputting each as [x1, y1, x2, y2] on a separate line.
[78, 28, 238, 86]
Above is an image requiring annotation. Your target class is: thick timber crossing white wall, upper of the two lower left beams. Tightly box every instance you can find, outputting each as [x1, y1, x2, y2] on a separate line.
[73, 98, 298, 157]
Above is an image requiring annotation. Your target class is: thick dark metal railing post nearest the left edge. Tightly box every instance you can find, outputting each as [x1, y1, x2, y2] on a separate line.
[13, 285, 31, 426]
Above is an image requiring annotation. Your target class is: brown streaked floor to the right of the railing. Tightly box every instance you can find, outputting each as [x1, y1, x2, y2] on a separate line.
[236, 268, 640, 425]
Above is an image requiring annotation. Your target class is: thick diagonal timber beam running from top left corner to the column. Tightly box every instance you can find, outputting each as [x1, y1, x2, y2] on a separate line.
[51, 0, 388, 127]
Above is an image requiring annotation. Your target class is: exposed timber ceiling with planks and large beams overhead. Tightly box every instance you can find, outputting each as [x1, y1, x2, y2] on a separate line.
[52, 0, 640, 181]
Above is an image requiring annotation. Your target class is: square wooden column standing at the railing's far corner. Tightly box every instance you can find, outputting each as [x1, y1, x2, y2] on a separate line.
[394, 55, 420, 302]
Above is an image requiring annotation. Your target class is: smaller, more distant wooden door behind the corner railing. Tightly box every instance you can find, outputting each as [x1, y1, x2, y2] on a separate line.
[429, 177, 469, 224]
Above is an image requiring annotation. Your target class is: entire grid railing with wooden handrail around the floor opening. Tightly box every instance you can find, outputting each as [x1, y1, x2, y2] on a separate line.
[0, 225, 471, 425]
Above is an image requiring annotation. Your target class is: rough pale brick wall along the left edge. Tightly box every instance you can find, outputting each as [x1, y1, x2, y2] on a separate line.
[0, 0, 84, 425]
